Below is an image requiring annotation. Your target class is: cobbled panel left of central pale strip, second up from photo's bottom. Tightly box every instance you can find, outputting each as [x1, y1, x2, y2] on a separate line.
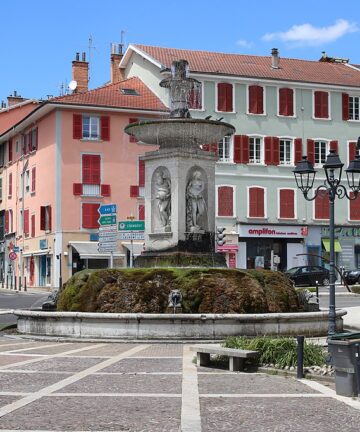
[59, 374, 181, 394]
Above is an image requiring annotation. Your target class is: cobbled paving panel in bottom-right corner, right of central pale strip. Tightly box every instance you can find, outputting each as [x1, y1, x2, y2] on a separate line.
[200, 398, 360, 432]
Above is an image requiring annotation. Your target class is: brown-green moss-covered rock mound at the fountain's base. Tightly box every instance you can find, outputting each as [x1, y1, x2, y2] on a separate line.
[58, 268, 299, 313]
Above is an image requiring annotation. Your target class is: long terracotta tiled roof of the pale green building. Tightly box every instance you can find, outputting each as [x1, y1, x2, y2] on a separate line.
[134, 44, 360, 87]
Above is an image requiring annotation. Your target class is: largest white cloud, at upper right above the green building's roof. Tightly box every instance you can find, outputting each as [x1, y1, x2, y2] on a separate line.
[262, 19, 359, 46]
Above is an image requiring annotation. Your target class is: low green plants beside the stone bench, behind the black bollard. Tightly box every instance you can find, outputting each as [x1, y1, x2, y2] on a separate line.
[224, 336, 326, 368]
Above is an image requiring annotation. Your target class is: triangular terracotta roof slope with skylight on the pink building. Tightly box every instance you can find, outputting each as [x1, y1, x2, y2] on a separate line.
[50, 77, 167, 111]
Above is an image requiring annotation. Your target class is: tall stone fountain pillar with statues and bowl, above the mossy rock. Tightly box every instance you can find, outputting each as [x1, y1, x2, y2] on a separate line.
[125, 60, 235, 267]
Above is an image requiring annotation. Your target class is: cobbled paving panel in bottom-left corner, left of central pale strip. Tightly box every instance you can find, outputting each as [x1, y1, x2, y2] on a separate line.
[1, 397, 181, 432]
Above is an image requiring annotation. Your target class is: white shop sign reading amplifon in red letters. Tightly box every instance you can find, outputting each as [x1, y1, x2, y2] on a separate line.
[239, 225, 309, 238]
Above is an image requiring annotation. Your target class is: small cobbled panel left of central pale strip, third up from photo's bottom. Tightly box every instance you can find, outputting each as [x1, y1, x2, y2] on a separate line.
[102, 357, 182, 373]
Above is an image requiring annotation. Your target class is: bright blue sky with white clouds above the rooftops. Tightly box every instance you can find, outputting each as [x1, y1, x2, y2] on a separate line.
[0, 0, 360, 100]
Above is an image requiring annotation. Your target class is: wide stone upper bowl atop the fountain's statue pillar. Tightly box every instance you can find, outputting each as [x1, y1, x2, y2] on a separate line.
[124, 118, 235, 148]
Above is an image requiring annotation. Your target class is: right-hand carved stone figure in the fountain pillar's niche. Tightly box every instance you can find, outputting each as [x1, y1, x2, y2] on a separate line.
[186, 171, 206, 232]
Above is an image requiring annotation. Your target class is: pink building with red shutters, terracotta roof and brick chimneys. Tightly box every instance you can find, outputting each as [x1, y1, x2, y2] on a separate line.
[0, 52, 167, 287]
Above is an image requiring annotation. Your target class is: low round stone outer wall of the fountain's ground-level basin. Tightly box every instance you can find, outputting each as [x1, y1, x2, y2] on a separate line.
[13, 309, 346, 340]
